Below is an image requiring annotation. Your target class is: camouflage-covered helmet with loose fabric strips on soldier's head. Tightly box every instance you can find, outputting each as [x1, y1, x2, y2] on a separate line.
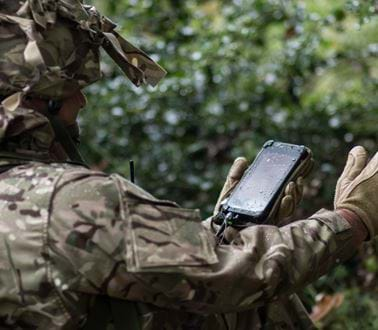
[0, 0, 165, 100]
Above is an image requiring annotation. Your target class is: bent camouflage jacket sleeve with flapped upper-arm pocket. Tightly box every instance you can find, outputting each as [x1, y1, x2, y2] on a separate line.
[49, 171, 355, 313]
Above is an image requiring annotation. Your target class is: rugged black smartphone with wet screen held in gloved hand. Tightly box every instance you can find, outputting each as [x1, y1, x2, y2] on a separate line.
[216, 140, 311, 227]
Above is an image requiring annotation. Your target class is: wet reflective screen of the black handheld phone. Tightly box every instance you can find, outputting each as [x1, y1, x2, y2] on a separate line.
[227, 144, 305, 217]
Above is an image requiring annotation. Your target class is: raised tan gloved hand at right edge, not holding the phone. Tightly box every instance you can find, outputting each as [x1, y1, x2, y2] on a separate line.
[334, 146, 378, 239]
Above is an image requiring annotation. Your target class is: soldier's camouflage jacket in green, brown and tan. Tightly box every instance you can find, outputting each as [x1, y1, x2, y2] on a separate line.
[0, 107, 354, 330]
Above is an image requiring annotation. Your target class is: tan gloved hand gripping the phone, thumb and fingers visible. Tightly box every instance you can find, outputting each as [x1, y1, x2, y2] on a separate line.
[213, 156, 313, 224]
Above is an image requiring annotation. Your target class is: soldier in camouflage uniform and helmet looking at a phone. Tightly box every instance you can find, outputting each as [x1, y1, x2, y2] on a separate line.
[0, 0, 378, 329]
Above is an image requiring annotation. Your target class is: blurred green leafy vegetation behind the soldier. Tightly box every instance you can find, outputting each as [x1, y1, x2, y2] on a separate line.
[81, 0, 378, 329]
